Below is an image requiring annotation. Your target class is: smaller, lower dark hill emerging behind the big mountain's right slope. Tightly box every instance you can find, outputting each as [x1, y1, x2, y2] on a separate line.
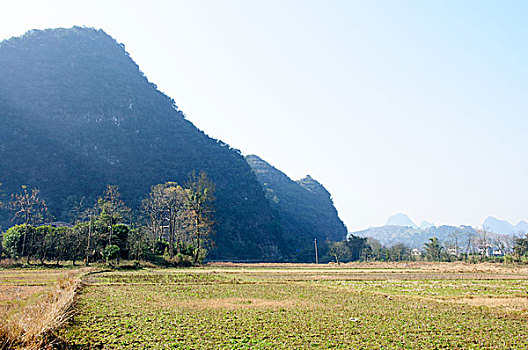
[246, 155, 347, 260]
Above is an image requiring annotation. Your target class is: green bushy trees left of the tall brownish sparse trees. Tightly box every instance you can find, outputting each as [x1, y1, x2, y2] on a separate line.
[2, 185, 133, 265]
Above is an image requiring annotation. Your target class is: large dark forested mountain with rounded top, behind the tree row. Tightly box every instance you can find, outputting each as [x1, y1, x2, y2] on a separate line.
[0, 27, 285, 259]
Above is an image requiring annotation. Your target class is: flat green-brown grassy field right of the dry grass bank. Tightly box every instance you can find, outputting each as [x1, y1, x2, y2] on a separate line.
[52, 263, 528, 349]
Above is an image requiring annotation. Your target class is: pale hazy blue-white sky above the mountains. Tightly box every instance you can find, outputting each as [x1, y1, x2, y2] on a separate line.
[0, 0, 528, 231]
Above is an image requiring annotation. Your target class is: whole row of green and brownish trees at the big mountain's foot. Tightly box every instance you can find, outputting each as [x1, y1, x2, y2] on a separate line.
[0, 172, 215, 265]
